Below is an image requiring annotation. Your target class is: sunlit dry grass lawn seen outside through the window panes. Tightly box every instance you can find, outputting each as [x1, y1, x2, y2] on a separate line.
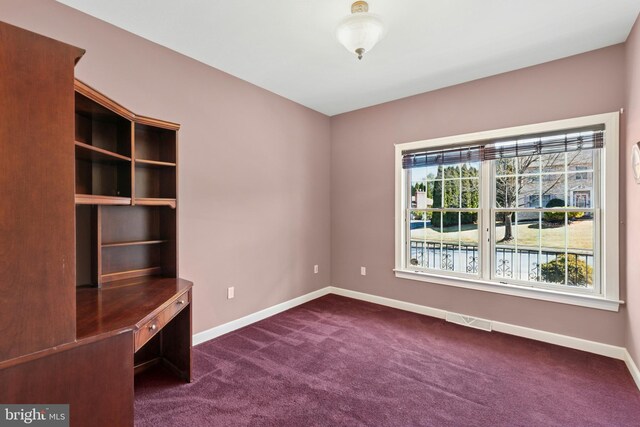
[411, 220, 593, 250]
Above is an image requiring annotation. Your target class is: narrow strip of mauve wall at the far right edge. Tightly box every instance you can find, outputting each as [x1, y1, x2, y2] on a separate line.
[623, 16, 640, 364]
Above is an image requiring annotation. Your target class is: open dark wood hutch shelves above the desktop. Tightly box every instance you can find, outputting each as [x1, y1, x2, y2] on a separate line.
[75, 82, 179, 287]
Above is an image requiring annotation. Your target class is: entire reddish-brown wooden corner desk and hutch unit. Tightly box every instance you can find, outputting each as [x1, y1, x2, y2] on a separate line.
[0, 22, 192, 426]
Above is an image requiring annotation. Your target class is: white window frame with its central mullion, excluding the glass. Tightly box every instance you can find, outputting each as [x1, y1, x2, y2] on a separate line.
[394, 112, 624, 311]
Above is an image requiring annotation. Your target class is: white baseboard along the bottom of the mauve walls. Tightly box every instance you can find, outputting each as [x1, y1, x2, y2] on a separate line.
[193, 286, 640, 389]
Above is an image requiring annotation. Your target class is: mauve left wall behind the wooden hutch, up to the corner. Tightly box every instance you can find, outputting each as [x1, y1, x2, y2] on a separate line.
[0, 0, 330, 332]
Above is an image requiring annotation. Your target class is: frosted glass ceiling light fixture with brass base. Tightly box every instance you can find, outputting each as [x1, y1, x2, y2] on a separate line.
[336, 1, 385, 59]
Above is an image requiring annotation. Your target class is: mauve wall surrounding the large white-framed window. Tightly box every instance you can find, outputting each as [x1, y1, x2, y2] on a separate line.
[331, 45, 626, 345]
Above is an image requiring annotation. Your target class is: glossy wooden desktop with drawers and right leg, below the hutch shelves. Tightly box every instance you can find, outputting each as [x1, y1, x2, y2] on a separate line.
[76, 277, 193, 382]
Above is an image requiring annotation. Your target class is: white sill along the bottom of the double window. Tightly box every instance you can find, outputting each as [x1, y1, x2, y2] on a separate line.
[394, 269, 624, 312]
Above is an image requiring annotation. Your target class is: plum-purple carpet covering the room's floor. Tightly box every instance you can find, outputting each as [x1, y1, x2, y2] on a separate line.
[135, 295, 640, 427]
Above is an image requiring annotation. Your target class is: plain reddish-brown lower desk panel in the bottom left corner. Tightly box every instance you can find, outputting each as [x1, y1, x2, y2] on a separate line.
[0, 332, 133, 427]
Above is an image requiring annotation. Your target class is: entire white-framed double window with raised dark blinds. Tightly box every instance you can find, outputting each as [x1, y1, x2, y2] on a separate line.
[396, 113, 619, 310]
